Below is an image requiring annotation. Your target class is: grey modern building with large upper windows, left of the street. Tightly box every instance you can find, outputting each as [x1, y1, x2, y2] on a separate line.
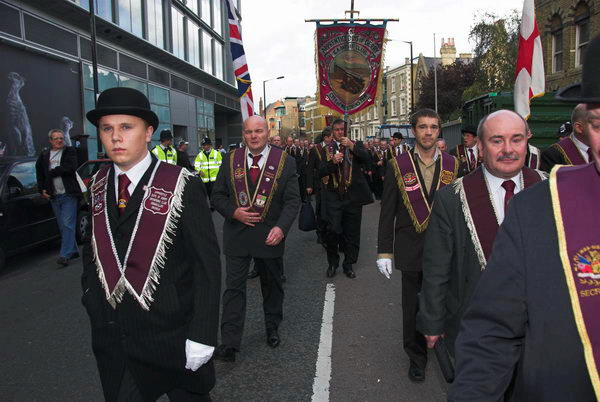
[0, 0, 241, 163]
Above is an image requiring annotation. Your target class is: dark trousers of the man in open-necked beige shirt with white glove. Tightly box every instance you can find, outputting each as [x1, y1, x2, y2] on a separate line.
[402, 271, 427, 369]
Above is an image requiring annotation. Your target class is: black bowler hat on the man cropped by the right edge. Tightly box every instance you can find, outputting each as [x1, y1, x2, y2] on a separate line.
[556, 35, 600, 103]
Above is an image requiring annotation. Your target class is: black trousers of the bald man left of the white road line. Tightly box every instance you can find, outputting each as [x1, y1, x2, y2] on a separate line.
[221, 255, 283, 351]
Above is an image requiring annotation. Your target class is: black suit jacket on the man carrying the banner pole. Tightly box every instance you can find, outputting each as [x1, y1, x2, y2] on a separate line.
[319, 141, 373, 206]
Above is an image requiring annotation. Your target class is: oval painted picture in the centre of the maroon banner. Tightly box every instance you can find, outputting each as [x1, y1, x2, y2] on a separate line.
[328, 50, 371, 105]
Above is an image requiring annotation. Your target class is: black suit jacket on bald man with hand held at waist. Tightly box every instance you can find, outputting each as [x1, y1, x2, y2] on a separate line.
[211, 152, 300, 258]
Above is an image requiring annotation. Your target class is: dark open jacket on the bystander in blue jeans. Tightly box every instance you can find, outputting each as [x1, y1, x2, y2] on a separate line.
[35, 147, 81, 196]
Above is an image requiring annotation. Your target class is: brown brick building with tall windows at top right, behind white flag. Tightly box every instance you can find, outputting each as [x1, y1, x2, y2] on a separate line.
[535, 0, 600, 92]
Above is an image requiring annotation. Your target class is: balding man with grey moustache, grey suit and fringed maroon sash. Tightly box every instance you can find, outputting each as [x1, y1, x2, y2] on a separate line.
[417, 110, 544, 355]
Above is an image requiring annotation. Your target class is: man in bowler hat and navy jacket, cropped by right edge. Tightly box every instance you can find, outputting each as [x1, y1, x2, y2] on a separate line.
[448, 36, 600, 401]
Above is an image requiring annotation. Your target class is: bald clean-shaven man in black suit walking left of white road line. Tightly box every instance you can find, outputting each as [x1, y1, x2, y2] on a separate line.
[211, 116, 300, 362]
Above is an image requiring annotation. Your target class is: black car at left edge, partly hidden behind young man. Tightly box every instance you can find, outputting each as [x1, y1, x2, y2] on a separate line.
[0, 157, 87, 271]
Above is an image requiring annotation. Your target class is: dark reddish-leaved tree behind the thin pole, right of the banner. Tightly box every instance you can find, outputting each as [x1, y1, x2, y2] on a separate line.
[416, 61, 475, 120]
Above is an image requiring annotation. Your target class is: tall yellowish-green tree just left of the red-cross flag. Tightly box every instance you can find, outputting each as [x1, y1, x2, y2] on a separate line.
[462, 10, 521, 101]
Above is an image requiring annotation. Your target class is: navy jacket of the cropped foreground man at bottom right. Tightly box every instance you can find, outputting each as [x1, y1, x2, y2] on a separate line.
[449, 181, 596, 401]
